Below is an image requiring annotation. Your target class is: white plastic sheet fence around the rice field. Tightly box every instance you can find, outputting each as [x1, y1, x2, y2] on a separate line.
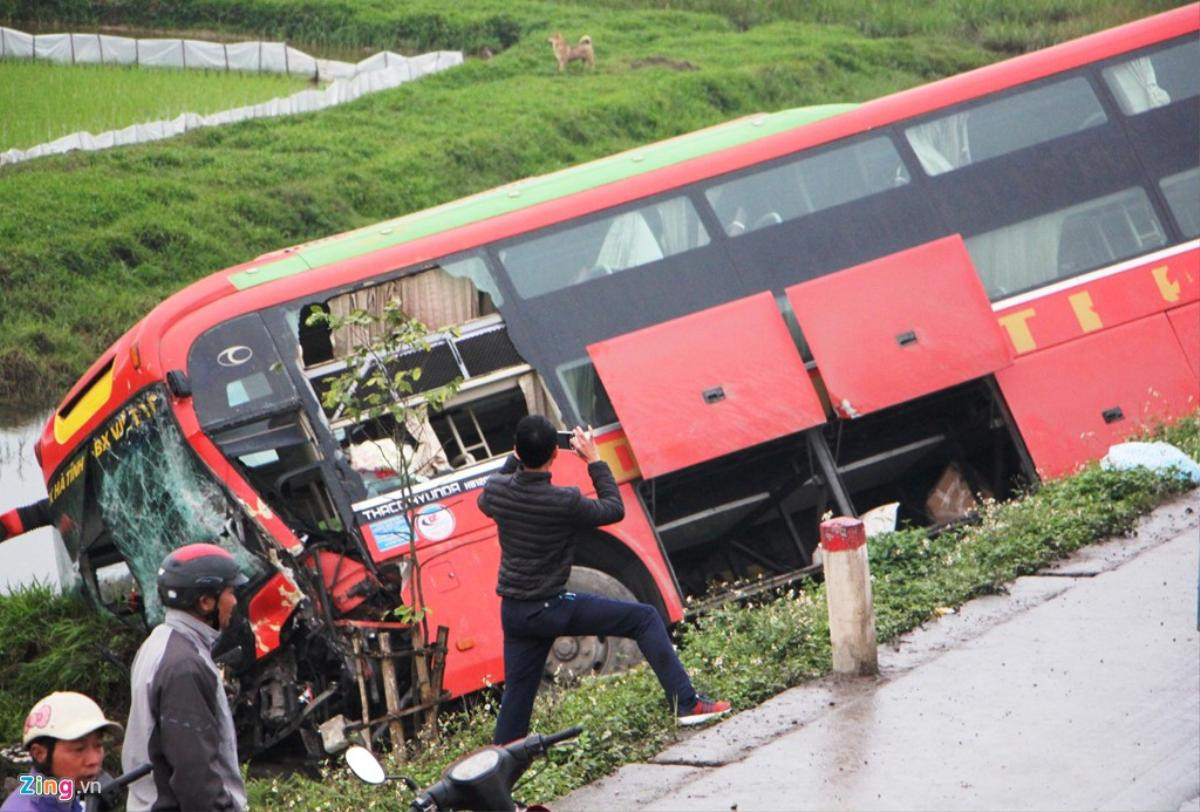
[0, 26, 462, 167]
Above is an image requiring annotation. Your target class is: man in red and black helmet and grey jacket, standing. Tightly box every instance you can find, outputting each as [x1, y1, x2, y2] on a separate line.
[121, 545, 246, 812]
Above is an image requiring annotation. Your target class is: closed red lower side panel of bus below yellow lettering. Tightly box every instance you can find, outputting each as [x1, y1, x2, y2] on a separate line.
[996, 315, 1200, 477]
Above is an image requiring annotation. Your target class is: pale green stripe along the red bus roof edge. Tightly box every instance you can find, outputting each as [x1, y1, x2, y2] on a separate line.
[229, 104, 858, 290]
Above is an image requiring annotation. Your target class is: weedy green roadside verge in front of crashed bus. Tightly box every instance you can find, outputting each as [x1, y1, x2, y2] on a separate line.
[0, 413, 1200, 811]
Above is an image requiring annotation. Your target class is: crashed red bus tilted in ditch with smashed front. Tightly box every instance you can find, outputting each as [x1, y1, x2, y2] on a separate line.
[11, 5, 1200, 753]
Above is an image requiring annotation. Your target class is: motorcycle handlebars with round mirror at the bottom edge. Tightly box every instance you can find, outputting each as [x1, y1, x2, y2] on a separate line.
[346, 726, 583, 812]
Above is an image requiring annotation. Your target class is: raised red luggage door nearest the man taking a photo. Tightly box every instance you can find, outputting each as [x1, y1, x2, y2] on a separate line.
[588, 293, 826, 477]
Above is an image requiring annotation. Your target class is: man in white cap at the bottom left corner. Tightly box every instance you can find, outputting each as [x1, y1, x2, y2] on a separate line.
[0, 691, 124, 812]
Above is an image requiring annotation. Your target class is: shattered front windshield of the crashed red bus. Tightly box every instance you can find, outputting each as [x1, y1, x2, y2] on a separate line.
[52, 387, 263, 626]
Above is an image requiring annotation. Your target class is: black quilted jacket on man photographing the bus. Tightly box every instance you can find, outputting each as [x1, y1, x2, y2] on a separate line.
[479, 456, 625, 601]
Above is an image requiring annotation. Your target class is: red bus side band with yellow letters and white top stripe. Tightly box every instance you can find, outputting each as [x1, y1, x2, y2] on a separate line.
[996, 242, 1200, 355]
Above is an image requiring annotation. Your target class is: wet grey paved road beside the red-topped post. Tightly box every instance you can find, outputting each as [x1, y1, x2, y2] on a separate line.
[552, 492, 1200, 812]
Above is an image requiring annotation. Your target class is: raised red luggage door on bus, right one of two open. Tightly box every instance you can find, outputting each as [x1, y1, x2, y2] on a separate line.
[787, 235, 1012, 412]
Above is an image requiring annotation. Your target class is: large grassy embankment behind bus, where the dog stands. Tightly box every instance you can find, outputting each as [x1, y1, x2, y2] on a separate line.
[0, 0, 1171, 414]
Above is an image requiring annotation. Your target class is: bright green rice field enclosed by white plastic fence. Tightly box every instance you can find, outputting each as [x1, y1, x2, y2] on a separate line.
[0, 59, 310, 151]
